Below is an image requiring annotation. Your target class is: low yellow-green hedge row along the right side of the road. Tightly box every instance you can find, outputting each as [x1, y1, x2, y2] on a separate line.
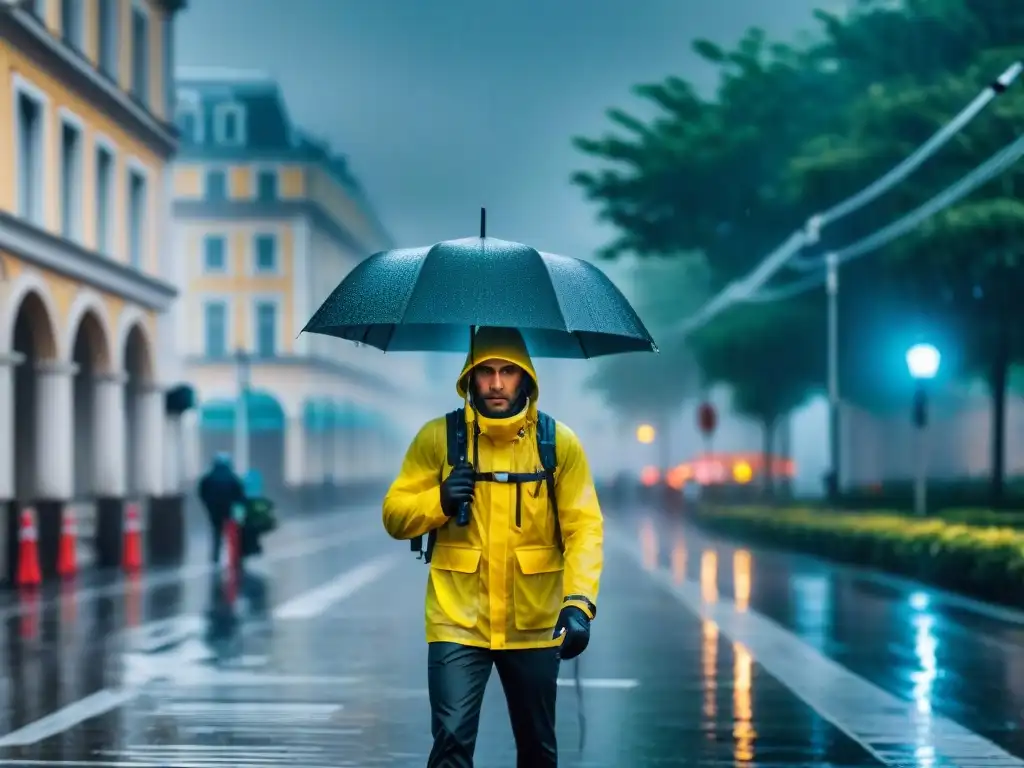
[693, 507, 1024, 606]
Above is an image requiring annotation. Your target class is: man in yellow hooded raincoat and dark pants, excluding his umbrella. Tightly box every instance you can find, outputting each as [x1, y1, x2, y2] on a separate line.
[384, 328, 603, 768]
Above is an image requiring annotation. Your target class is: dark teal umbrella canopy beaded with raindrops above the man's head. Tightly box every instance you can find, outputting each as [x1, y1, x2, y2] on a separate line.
[303, 231, 657, 358]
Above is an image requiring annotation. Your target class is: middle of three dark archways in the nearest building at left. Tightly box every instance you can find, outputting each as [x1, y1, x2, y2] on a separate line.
[72, 310, 112, 500]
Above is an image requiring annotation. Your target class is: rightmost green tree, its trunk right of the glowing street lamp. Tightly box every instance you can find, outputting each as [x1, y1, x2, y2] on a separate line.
[792, 37, 1024, 505]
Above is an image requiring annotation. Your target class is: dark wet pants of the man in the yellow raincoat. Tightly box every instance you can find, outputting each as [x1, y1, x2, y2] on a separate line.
[427, 643, 558, 768]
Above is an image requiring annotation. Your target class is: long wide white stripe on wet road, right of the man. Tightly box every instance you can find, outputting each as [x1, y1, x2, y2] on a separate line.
[606, 538, 1024, 768]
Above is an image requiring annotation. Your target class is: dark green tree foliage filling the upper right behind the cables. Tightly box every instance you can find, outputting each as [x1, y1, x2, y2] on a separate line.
[573, 0, 1024, 501]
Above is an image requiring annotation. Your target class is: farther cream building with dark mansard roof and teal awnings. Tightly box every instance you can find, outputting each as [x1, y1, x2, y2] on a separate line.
[174, 69, 436, 505]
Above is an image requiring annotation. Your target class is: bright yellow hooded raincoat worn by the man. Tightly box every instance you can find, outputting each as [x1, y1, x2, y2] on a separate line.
[384, 328, 604, 649]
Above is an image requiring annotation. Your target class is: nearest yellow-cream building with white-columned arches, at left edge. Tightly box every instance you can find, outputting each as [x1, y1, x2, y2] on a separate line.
[0, 0, 183, 571]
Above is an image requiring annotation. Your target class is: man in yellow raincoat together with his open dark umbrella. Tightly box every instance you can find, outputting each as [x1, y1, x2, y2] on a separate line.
[303, 209, 657, 768]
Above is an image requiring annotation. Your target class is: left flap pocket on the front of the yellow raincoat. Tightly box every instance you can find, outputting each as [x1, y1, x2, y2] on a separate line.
[427, 544, 480, 629]
